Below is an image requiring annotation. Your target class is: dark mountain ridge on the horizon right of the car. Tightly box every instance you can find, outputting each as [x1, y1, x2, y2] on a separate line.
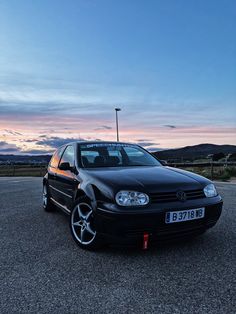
[153, 144, 236, 161]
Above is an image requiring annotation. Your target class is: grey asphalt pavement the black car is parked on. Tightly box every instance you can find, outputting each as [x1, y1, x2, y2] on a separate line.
[0, 177, 236, 314]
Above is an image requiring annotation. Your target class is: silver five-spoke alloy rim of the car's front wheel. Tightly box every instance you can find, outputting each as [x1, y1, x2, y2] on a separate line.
[71, 203, 96, 245]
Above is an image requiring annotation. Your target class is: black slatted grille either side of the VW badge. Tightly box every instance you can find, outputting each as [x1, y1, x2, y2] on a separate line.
[150, 189, 206, 203]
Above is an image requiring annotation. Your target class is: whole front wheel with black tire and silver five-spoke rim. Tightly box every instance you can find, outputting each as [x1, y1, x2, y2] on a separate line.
[70, 197, 103, 250]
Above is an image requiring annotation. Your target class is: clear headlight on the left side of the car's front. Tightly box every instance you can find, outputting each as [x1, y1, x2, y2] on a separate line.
[116, 191, 149, 206]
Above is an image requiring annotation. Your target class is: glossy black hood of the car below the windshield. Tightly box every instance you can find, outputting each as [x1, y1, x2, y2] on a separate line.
[80, 166, 210, 193]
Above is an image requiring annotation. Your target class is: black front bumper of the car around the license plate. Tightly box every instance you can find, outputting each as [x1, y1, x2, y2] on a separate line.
[95, 196, 223, 244]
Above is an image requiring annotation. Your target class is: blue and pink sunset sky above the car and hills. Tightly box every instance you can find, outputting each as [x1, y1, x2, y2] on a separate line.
[0, 0, 236, 154]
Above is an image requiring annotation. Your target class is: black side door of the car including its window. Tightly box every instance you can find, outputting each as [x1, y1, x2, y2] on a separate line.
[55, 145, 78, 209]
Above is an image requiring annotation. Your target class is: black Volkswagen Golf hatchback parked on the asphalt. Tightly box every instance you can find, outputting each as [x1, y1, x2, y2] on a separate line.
[43, 142, 223, 249]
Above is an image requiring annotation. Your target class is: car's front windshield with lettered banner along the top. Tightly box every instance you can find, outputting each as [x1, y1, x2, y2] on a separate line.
[80, 143, 161, 168]
